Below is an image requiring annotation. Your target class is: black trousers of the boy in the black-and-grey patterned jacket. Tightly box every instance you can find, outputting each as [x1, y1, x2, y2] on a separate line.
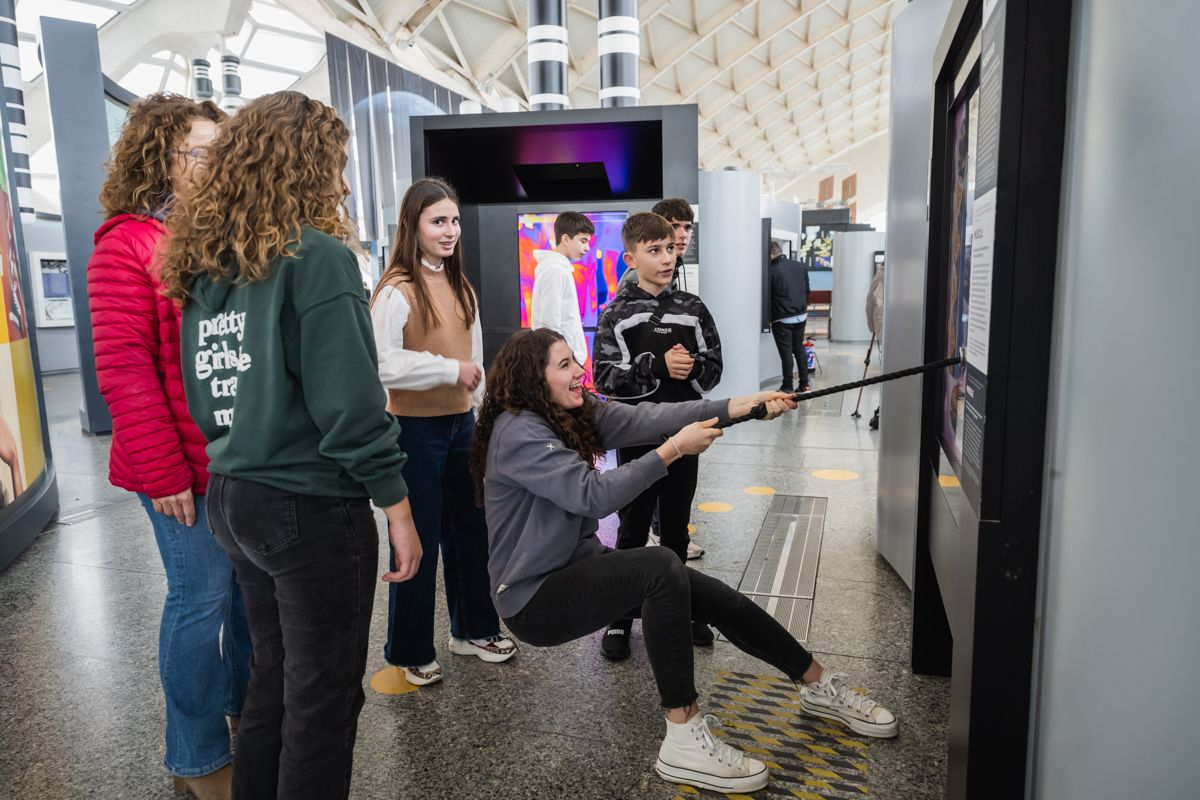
[617, 446, 700, 561]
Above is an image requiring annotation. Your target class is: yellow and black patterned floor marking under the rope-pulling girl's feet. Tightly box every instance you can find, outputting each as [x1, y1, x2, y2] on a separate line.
[676, 672, 871, 800]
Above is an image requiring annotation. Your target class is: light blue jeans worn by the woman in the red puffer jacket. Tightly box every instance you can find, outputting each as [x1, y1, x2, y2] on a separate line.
[138, 494, 251, 777]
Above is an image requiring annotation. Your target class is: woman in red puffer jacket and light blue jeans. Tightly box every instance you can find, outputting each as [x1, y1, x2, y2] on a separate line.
[88, 95, 251, 800]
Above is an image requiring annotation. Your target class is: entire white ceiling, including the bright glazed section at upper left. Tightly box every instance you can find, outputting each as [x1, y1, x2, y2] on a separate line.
[17, 0, 907, 205]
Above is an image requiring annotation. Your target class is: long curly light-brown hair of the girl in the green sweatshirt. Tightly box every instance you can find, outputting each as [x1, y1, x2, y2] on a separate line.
[162, 91, 356, 303]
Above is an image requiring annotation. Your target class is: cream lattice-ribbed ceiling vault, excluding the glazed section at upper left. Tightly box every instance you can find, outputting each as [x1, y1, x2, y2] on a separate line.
[316, 0, 907, 197]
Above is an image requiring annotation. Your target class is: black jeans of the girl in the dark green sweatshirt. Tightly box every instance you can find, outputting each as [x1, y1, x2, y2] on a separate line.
[208, 475, 379, 800]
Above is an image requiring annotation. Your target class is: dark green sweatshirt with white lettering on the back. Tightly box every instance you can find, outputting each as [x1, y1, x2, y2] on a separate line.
[181, 228, 408, 506]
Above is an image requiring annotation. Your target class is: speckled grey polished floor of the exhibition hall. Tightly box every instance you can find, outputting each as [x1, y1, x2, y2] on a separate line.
[0, 342, 949, 800]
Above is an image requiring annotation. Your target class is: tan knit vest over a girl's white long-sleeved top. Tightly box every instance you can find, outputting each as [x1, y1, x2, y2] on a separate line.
[388, 270, 470, 416]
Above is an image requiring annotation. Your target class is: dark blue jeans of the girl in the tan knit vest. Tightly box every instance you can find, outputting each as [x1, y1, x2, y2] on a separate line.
[384, 411, 500, 667]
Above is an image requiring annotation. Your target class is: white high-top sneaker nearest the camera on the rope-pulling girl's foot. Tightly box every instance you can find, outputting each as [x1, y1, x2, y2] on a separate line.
[654, 714, 770, 792]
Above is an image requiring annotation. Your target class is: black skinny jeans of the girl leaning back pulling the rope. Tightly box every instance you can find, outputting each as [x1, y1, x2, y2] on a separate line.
[504, 547, 812, 709]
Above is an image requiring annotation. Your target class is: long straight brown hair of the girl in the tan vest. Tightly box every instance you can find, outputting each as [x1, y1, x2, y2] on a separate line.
[371, 178, 476, 330]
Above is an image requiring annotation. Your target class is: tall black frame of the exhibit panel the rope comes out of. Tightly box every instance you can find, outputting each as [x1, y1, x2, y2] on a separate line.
[912, 0, 1070, 800]
